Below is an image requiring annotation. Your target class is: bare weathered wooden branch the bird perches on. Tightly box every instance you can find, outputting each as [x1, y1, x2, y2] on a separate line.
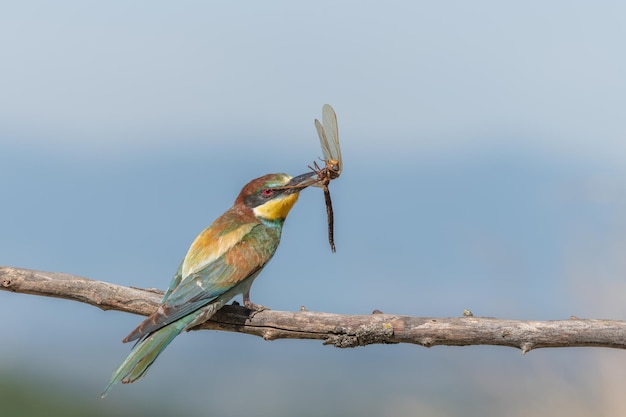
[0, 267, 626, 353]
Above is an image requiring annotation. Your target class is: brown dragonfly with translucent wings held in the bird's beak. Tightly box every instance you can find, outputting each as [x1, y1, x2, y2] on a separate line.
[309, 104, 343, 252]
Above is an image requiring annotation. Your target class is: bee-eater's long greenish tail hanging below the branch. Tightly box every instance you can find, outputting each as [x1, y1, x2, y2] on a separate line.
[101, 314, 195, 398]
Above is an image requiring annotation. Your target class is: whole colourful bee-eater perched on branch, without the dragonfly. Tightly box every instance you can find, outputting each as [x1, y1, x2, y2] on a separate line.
[102, 172, 317, 398]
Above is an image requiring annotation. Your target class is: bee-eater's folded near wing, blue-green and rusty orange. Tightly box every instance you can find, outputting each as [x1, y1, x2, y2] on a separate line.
[124, 224, 280, 342]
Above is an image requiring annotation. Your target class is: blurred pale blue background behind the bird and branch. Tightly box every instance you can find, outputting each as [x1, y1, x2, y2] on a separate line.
[0, 0, 626, 417]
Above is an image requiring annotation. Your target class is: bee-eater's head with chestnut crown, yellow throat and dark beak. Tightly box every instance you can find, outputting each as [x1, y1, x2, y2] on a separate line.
[235, 172, 317, 222]
